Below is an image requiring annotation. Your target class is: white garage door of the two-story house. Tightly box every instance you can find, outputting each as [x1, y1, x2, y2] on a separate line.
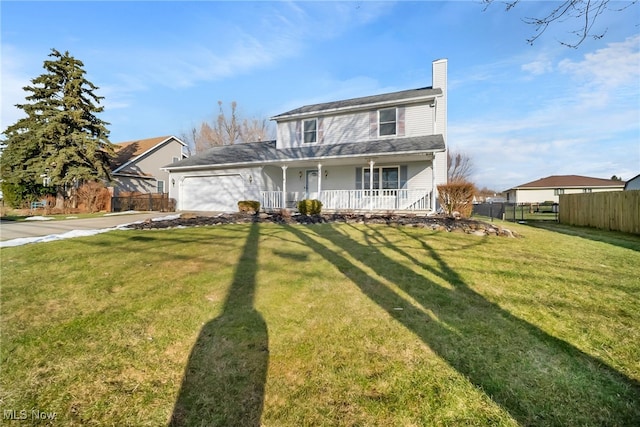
[180, 175, 244, 212]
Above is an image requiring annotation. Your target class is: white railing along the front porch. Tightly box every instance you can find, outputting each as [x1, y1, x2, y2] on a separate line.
[261, 189, 431, 211]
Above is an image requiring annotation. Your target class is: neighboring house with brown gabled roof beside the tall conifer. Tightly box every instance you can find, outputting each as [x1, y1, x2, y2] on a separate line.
[111, 136, 186, 195]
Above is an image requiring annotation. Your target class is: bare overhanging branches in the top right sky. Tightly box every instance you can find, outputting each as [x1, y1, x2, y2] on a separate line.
[482, 0, 638, 48]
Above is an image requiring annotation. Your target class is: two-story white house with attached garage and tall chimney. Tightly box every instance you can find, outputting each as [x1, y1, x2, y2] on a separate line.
[165, 60, 447, 211]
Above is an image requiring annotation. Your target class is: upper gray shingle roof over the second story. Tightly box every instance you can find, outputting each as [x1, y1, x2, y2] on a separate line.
[272, 87, 442, 120]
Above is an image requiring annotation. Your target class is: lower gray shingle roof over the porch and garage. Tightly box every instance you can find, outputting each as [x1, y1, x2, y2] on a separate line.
[163, 135, 445, 171]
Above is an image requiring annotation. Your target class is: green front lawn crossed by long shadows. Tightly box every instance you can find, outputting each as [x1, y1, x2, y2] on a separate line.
[0, 223, 640, 426]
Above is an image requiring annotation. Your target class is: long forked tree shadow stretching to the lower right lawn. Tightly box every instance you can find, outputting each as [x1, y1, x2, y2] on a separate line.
[289, 225, 640, 426]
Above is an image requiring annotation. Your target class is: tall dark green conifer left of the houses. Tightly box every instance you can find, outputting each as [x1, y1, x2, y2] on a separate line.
[0, 49, 113, 208]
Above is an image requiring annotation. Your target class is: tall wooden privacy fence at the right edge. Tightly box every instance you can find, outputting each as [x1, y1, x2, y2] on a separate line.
[558, 190, 640, 234]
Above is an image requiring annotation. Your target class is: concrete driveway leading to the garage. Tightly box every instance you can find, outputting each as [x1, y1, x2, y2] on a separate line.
[0, 212, 174, 241]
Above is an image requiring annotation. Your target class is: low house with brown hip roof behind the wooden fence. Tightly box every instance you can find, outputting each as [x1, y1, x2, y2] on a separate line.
[505, 175, 624, 203]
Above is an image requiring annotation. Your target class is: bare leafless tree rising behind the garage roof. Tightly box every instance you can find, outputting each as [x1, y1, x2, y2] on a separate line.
[182, 101, 274, 152]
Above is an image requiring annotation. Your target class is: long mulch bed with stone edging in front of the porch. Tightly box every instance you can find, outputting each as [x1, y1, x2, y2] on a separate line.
[129, 213, 521, 237]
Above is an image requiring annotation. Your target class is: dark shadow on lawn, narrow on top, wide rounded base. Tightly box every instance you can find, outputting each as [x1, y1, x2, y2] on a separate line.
[169, 223, 269, 427]
